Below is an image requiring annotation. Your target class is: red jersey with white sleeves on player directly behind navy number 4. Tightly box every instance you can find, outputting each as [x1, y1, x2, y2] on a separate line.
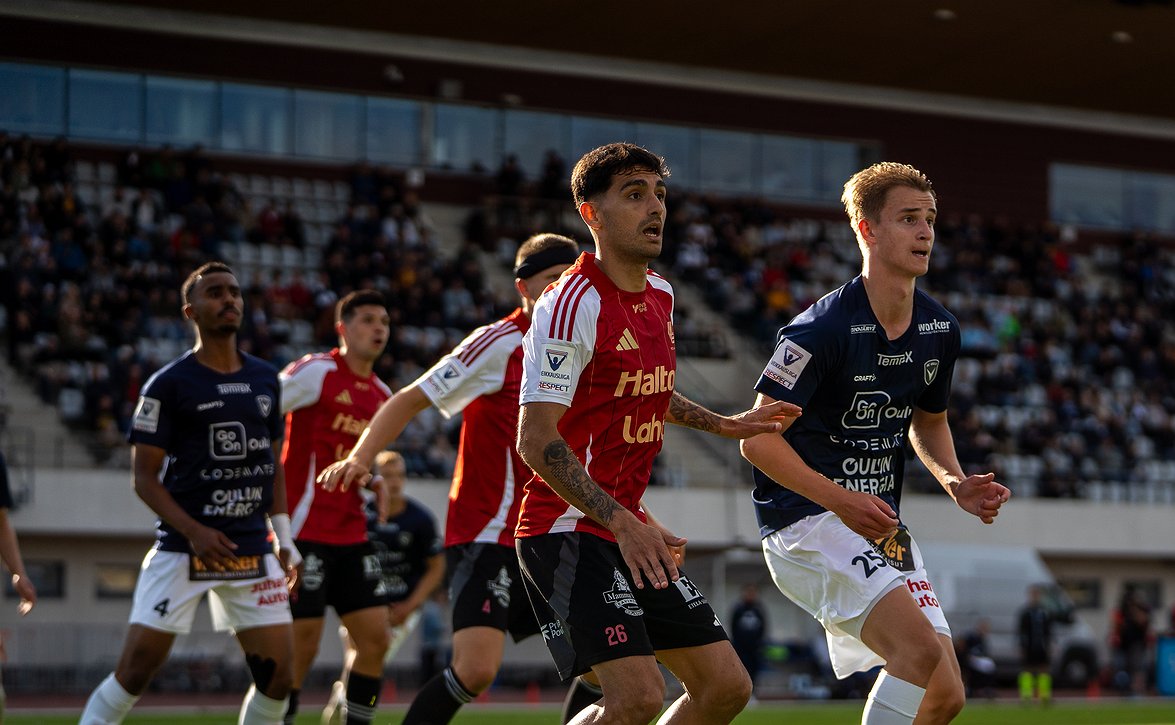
[278, 348, 391, 545]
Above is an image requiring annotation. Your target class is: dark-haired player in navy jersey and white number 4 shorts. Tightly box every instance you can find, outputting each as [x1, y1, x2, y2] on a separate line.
[80, 262, 297, 725]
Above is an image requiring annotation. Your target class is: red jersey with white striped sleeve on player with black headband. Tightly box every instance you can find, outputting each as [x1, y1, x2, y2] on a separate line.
[414, 308, 531, 548]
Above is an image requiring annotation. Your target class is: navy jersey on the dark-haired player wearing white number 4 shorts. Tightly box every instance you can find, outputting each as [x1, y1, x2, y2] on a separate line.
[127, 350, 283, 556]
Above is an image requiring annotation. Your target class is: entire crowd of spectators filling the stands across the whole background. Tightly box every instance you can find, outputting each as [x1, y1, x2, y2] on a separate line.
[0, 132, 1175, 497]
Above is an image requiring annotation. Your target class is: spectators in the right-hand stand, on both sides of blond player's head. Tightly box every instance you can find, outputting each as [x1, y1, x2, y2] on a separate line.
[665, 195, 1175, 501]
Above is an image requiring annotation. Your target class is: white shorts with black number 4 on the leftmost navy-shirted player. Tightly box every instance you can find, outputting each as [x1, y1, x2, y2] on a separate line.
[130, 549, 293, 635]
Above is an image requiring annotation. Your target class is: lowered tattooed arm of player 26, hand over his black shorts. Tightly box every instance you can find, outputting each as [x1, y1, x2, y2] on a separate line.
[518, 403, 678, 589]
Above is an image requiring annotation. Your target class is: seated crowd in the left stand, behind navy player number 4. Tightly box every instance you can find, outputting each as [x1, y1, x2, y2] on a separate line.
[0, 133, 508, 476]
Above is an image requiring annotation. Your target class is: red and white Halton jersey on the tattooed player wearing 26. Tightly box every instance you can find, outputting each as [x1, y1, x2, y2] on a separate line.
[517, 253, 677, 541]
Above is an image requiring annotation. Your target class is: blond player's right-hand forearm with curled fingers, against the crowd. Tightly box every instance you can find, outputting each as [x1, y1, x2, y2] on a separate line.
[909, 408, 1012, 524]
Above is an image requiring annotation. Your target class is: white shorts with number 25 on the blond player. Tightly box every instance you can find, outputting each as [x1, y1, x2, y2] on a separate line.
[763, 511, 951, 679]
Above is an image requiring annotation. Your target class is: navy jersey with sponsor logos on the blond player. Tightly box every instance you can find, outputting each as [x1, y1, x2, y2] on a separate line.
[754, 277, 959, 536]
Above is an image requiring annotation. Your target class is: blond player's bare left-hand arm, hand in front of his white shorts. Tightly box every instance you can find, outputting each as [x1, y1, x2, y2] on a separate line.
[739, 394, 898, 539]
